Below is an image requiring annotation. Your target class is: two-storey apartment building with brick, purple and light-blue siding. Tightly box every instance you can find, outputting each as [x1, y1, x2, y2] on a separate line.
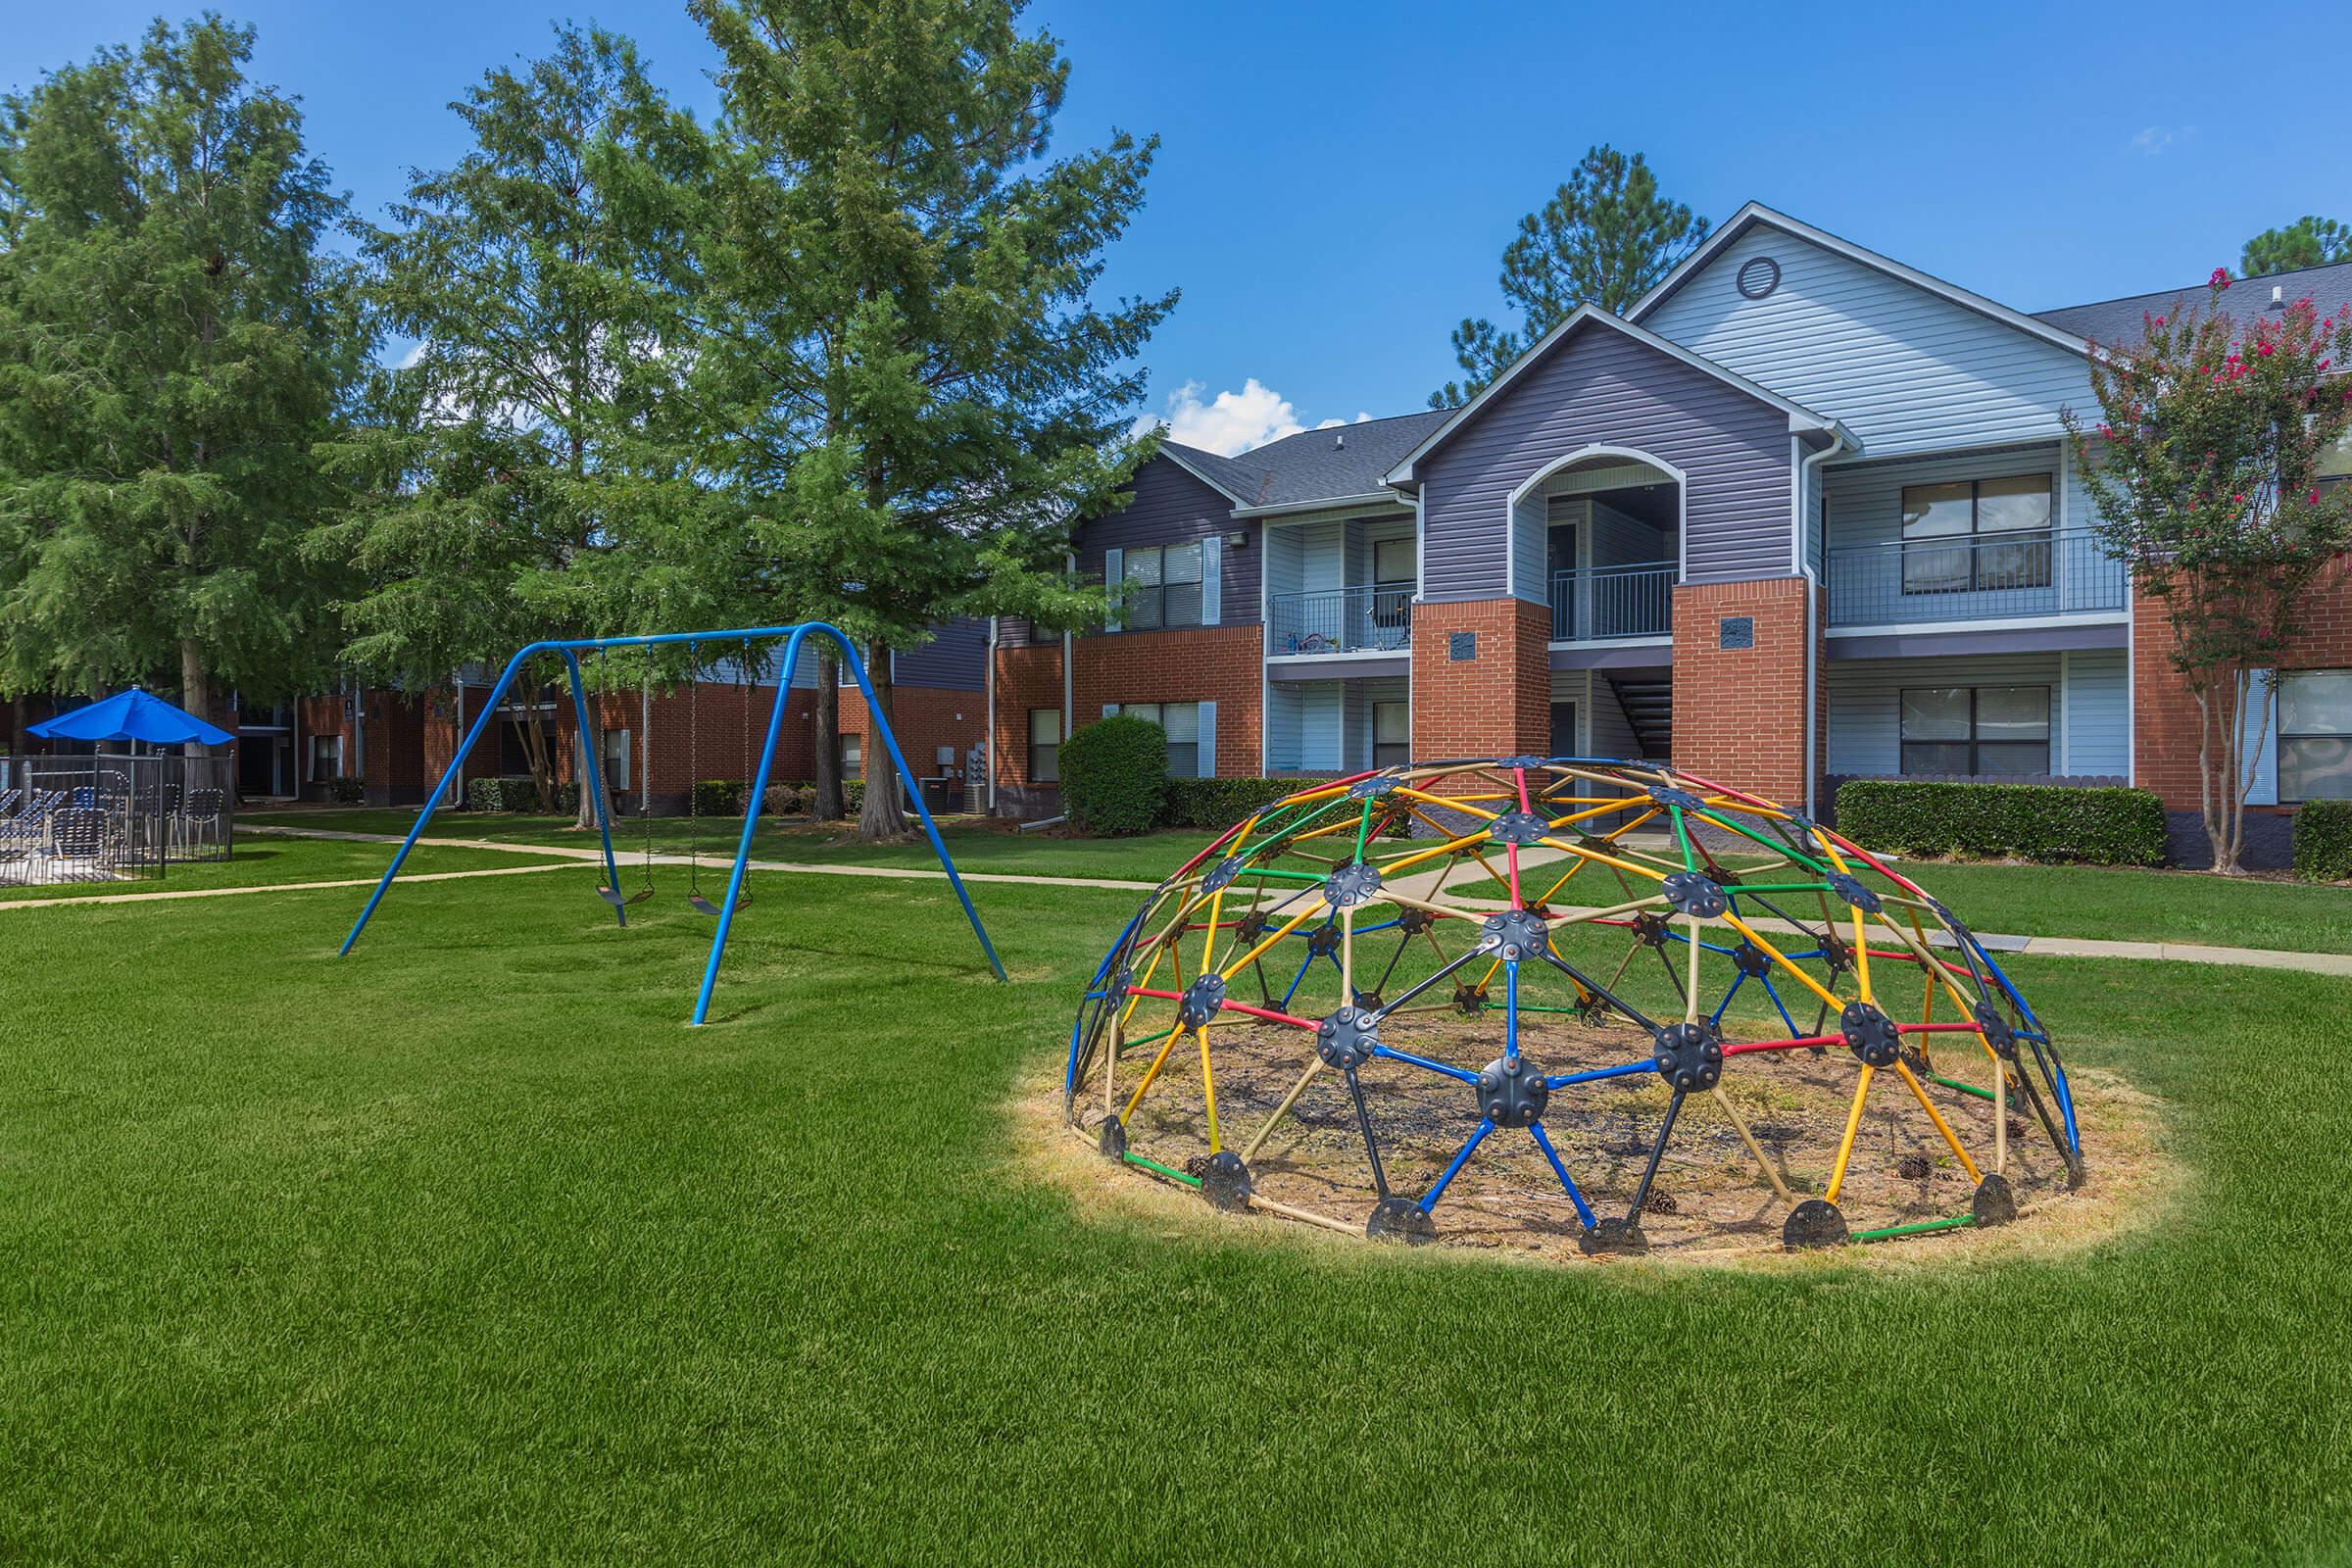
[990, 205, 2352, 864]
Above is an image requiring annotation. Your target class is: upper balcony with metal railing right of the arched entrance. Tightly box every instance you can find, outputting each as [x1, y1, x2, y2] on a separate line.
[1825, 529, 2124, 625]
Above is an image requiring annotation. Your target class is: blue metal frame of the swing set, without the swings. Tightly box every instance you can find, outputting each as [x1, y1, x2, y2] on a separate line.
[336, 620, 1004, 1022]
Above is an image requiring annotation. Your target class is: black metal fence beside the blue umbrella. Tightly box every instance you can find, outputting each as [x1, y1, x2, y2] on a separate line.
[0, 753, 235, 886]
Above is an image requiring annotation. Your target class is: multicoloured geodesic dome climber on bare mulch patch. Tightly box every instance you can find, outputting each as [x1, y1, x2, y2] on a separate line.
[1063, 757, 2083, 1253]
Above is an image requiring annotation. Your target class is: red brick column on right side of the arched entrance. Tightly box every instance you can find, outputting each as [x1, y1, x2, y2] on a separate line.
[1675, 576, 1821, 808]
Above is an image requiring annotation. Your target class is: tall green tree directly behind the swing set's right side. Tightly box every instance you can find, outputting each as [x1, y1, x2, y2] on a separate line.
[694, 0, 1176, 839]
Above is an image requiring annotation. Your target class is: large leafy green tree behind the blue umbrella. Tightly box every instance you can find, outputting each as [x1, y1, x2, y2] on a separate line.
[0, 17, 371, 747]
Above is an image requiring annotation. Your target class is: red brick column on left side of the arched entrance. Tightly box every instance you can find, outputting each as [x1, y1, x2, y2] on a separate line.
[1413, 600, 1552, 761]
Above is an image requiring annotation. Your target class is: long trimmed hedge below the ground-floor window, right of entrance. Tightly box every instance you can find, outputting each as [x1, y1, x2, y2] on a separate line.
[1837, 778, 2166, 865]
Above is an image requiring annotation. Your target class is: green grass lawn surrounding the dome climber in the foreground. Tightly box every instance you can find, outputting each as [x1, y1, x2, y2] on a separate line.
[0, 864, 2352, 1563]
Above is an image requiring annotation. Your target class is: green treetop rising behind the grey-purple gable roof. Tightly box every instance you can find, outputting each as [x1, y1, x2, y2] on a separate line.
[1430, 143, 1710, 409]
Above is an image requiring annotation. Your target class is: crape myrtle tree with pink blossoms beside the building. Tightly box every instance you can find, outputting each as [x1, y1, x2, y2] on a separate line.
[2063, 270, 2352, 874]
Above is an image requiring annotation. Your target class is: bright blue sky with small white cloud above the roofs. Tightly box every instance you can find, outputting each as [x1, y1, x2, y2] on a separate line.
[14, 0, 2352, 447]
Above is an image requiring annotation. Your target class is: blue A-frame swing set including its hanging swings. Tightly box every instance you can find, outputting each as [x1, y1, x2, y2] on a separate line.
[336, 620, 1004, 1022]
